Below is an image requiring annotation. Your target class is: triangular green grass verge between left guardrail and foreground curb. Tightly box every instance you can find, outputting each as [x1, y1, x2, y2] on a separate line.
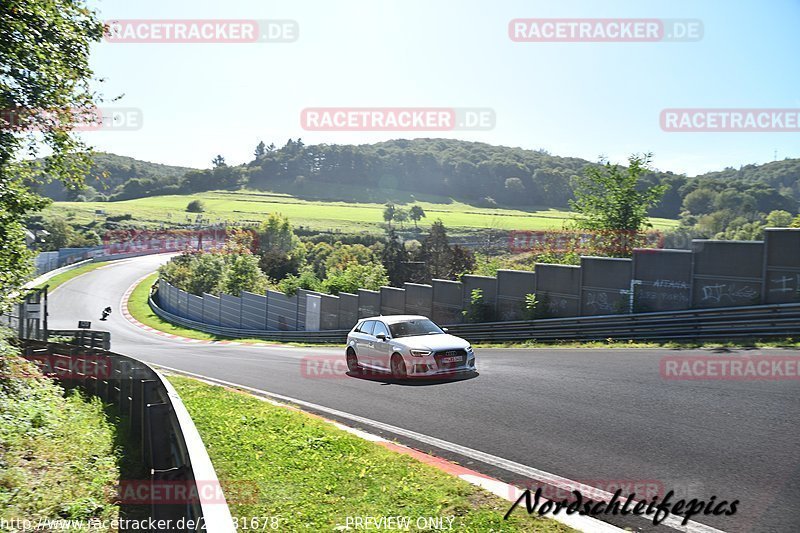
[169, 376, 570, 533]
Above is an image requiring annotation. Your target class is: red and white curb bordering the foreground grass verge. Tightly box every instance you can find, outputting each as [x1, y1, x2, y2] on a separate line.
[151, 363, 627, 533]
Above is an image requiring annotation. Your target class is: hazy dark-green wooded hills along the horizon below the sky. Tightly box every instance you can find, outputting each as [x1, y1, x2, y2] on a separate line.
[28, 139, 800, 218]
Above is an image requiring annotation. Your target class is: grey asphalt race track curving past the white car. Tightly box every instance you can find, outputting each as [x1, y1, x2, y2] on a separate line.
[49, 256, 800, 532]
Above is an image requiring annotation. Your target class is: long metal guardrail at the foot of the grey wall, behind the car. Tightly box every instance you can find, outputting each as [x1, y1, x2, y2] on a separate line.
[149, 290, 800, 343]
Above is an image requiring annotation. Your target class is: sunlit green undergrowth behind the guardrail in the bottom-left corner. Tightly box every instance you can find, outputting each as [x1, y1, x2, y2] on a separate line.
[0, 341, 119, 520]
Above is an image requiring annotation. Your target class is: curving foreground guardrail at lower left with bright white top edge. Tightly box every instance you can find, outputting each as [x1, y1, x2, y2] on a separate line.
[20, 340, 235, 533]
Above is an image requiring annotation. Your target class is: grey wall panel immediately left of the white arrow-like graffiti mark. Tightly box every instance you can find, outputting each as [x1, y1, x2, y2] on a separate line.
[581, 257, 633, 316]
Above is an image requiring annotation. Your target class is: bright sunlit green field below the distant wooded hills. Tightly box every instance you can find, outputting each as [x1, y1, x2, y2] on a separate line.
[48, 191, 677, 233]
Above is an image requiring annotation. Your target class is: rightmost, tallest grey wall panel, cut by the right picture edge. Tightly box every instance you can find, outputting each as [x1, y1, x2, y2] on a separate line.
[764, 228, 800, 304]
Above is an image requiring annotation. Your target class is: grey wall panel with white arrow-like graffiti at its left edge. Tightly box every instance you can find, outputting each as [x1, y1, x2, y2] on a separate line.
[633, 248, 692, 313]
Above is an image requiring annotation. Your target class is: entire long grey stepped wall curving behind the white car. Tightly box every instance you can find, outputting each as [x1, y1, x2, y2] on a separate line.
[152, 229, 800, 331]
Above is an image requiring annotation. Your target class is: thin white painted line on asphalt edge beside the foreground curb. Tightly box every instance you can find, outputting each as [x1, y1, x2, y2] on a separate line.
[148, 363, 724, 533]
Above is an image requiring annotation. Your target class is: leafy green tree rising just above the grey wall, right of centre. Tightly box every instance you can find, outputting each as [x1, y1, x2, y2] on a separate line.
[570, 154, 668, 256]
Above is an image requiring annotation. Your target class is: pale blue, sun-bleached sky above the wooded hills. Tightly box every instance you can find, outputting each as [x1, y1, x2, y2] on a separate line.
[83, 0, 800, 175]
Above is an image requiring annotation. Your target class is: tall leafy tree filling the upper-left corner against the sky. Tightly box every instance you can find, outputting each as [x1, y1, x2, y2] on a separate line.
[0, 0, 104, 312]
